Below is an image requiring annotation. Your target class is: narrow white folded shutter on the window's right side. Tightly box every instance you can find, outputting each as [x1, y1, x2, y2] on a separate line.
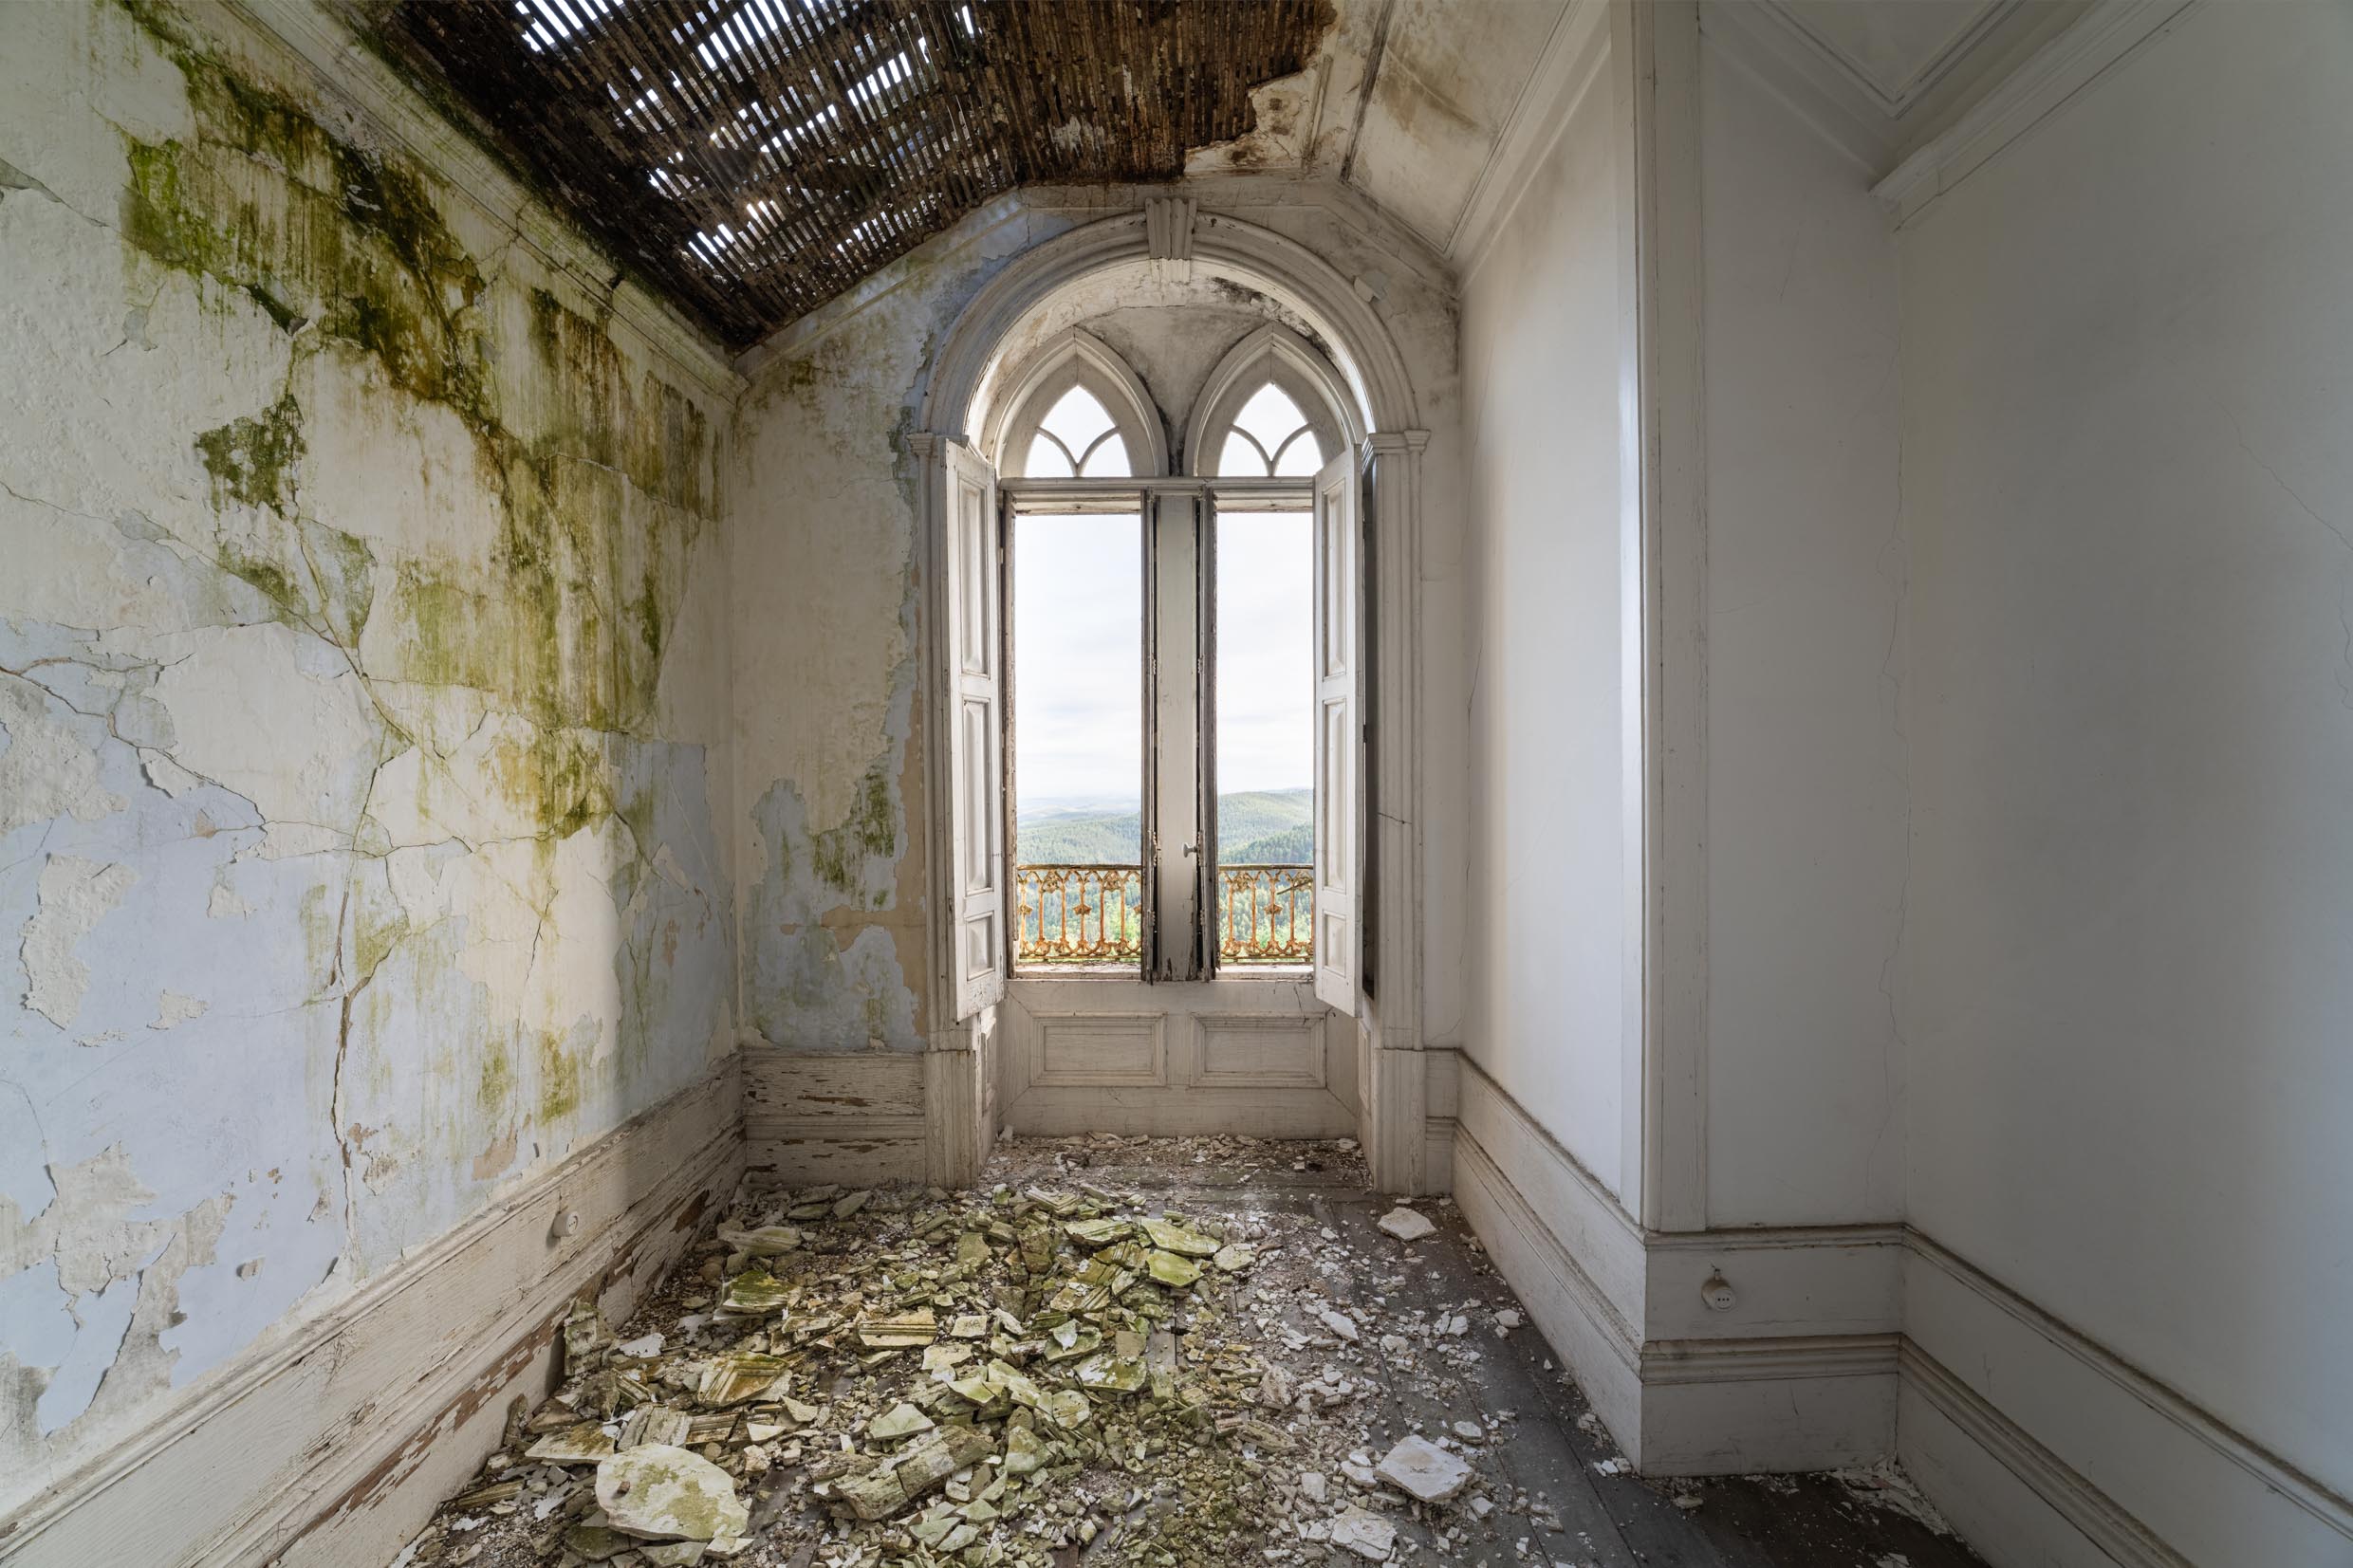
[1315, 452, 1364, 1016]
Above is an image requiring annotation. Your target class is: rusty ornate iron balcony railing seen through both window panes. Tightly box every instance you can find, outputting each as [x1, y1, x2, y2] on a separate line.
[1014, 865, 1315, 964]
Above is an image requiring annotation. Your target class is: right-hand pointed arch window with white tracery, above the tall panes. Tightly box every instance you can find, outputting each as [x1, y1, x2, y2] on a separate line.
[1186, 326, 1353, 480]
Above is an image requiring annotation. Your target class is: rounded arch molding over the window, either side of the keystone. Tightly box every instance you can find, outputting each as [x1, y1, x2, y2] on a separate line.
[920, 212, 1418, 442]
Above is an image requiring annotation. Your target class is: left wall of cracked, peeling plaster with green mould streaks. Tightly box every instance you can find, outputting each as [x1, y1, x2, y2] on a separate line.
[0, 0, 734, 1512]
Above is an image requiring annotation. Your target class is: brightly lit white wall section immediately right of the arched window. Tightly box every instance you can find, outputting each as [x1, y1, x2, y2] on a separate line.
[1433, 48, 1636, 1196]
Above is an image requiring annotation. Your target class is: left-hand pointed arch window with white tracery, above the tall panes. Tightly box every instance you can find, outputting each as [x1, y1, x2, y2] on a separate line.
[993, 329, 1167, 480]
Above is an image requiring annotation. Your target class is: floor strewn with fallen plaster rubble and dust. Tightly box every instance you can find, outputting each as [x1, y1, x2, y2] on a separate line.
[396, 1135, 1976, 1568]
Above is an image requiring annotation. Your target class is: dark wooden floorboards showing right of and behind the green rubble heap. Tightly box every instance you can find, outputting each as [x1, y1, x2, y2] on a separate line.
[1030, 1140, 1981, 1568]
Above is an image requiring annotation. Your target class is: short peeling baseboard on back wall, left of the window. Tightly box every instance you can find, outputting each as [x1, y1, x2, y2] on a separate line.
[739, 1043, 927, 1188]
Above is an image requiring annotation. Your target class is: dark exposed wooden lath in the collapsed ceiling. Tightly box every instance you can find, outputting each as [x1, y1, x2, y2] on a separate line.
[381, 0, 1332, 348]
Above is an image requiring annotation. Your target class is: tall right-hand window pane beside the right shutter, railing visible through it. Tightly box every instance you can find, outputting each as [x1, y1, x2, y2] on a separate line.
[1216, 512, 1315, 967]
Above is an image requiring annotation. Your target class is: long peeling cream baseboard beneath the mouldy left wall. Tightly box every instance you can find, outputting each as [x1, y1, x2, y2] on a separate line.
[0, 1058, 744, 1568]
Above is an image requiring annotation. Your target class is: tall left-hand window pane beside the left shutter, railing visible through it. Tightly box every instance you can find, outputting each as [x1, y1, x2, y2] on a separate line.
[1011, 512, 1143, 967]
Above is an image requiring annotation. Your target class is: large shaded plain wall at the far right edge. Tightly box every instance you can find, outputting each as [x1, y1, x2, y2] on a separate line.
[1891, 5, 2353, 1522]
